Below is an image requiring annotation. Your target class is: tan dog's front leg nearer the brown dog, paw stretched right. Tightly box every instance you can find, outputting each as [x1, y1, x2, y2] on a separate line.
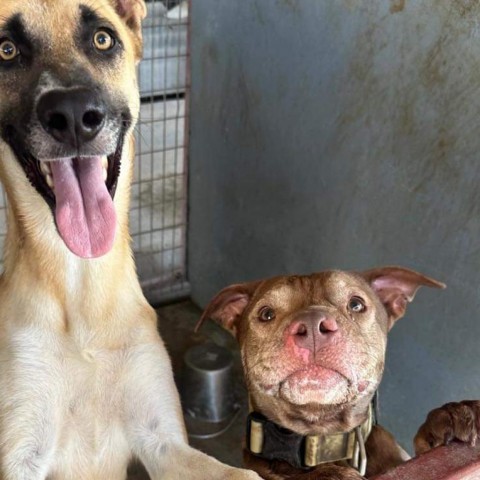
[126, 343, 260, 480]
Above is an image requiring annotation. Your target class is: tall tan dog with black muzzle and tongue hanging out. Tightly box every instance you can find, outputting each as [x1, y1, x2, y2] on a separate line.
[0, 0, 258, 480]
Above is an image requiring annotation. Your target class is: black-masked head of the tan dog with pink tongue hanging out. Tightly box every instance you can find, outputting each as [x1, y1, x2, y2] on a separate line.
[0, 0, 146, 258]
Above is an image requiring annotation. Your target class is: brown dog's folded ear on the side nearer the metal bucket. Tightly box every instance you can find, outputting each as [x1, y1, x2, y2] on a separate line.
[195, 281, 261, 336]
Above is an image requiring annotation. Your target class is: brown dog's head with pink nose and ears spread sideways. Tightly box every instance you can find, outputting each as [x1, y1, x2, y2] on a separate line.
[200, 267, 444, 434]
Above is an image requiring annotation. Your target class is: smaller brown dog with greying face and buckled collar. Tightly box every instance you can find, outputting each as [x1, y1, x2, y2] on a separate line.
[200, 267, 444, 480]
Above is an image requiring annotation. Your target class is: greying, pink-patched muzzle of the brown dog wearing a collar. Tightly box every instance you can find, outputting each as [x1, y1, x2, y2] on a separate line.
[251, 305, 384, 405]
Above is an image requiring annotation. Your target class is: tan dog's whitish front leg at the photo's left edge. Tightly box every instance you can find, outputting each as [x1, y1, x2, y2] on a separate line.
[0, 332, 62, 480]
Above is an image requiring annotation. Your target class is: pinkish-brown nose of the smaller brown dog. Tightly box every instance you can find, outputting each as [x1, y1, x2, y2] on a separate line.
[288, 311, 339, 352]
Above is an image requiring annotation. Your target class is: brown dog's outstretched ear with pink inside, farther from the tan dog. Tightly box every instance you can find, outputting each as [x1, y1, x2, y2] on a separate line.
[360, 267, 446, 330]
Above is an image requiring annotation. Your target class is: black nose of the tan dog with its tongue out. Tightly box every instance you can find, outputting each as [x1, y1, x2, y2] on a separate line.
[37, 88, 106, 148]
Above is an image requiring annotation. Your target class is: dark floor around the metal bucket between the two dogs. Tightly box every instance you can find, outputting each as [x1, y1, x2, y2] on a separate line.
[157, 301, 248, 466]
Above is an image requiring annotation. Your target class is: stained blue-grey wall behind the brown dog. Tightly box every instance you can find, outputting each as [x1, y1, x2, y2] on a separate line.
[189, 0, 480, 448]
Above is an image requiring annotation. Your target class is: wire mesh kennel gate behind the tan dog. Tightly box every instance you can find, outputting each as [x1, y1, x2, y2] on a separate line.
[0, 0, 189, 303]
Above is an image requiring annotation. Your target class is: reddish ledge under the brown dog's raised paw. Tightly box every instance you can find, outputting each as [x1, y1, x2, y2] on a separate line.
[372, 443, 480, 480]
